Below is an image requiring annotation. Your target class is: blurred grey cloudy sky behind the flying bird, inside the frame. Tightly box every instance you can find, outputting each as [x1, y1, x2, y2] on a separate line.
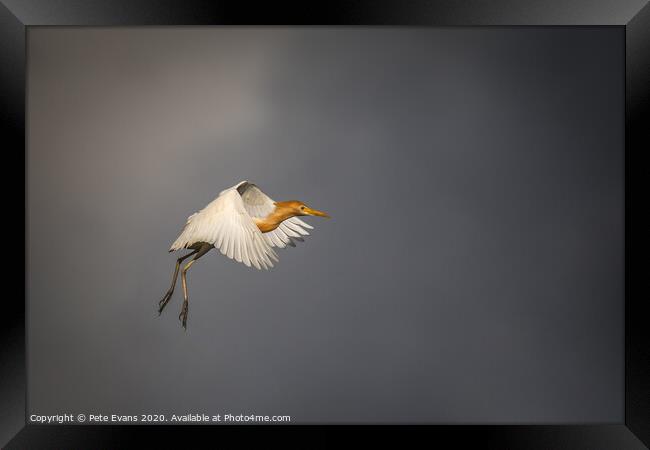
[27, 28, 624, 423]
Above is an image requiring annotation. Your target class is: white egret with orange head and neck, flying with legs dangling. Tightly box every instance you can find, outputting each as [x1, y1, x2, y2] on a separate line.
[158, 180, 330, 330]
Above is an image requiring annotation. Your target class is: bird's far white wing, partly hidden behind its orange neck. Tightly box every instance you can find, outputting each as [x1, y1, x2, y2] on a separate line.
[234, 181, 314, 248]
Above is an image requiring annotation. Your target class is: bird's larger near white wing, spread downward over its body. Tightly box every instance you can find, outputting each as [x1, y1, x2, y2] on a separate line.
[167, 187, 278, 269]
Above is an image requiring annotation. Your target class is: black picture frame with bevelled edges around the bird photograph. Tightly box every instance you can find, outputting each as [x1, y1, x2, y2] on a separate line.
[0, 0, 650, 449]
